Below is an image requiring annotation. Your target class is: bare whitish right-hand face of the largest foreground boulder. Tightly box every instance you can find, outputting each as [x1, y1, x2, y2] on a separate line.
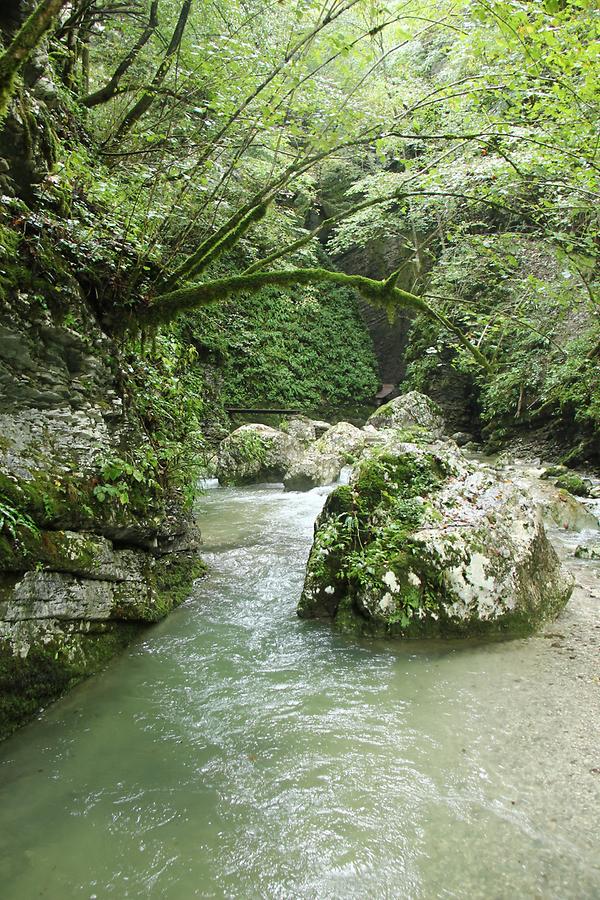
[400, 469, 573, 625]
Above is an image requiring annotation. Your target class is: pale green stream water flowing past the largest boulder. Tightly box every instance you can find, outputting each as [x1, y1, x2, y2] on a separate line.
[0, 487, 600, 900]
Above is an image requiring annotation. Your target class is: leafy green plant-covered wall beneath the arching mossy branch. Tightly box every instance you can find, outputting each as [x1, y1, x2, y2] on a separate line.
[190, 285, 378, 411]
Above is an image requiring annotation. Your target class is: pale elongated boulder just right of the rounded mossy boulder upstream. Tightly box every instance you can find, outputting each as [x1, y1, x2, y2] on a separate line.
[283, 422, 368, 491]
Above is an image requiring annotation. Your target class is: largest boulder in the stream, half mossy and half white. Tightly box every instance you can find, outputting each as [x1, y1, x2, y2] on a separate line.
[298, 441, 572, 638]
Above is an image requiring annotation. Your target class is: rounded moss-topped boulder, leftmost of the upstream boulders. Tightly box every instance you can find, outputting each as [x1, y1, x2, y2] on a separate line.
[217, 424, 303, 484]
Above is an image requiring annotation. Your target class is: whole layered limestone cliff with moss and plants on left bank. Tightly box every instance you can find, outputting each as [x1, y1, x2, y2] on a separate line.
[0, 237, 202, 737]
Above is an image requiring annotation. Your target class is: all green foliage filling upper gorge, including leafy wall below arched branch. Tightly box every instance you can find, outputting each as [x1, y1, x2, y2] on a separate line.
[0, 0, 600, 464]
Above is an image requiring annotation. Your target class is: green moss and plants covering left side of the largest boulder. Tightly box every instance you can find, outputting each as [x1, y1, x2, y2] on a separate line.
[300, 451, 443, 633]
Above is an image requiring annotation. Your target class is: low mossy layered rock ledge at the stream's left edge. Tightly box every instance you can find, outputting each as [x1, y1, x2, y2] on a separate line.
[0, 534, 206, 739]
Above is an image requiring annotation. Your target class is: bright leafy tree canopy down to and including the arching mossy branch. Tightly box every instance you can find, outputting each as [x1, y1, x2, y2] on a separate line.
[0, 0, 600, 366]
